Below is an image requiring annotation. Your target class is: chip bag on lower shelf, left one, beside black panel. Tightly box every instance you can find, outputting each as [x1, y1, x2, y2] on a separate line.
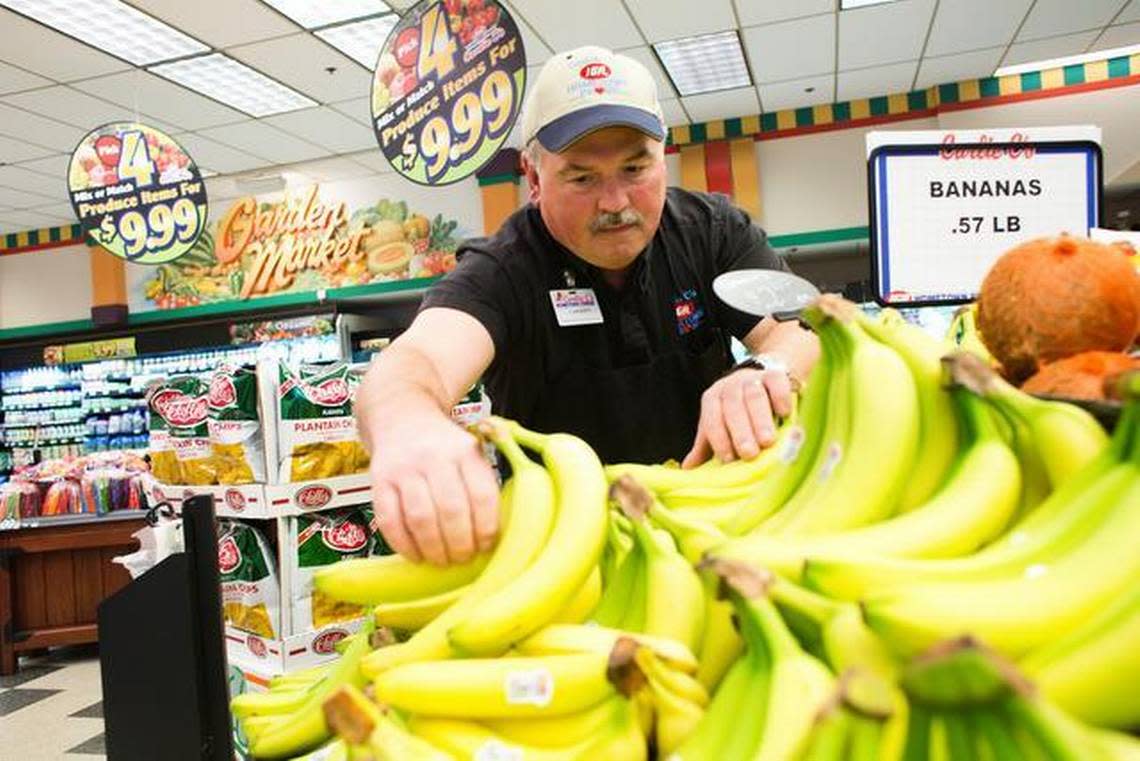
[218, 519, 282, 639]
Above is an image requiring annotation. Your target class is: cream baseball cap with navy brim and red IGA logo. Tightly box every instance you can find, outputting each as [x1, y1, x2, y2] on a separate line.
[522, 46, 666, 153]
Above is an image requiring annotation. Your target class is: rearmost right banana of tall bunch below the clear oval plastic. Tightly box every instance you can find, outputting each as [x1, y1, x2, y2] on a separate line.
[861, 309, 959, 513]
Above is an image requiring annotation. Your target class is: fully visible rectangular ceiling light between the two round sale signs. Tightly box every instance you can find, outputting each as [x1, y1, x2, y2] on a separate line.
[149, 52, 317, 116]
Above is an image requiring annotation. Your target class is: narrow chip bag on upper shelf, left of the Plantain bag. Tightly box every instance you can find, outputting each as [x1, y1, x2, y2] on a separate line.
[207, 365, 266, 484]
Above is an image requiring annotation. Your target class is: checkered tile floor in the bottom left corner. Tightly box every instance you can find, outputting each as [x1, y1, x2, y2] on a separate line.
[0, 647, 106, 761]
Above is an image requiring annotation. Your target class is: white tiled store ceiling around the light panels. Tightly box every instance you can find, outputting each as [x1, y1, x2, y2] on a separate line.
[0, 0, 1140, 234]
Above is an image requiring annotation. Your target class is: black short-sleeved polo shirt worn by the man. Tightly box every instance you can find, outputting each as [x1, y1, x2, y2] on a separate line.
[421, 188, 787, 461]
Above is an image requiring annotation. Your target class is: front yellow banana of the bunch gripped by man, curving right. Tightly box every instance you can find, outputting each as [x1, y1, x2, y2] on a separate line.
[448, 424, 609, 655]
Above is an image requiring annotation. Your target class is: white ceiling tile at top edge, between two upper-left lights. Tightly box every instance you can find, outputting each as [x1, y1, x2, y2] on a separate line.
[131, 0, 298, 48]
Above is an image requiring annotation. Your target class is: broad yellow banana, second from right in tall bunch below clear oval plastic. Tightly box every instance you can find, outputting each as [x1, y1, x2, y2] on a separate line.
[780, 295, 919, 534]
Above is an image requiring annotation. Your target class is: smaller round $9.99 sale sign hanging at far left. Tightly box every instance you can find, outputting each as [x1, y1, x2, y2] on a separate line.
[67, 122, 206, 264]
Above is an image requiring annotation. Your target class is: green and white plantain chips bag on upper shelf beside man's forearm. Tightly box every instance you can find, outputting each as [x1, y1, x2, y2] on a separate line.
[277, 362, 368, 482]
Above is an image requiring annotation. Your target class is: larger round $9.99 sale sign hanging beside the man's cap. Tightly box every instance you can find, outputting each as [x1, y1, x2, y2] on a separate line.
[372, 0, 527, 185]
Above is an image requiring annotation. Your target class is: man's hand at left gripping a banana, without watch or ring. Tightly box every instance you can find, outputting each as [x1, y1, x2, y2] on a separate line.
[369, 410, 499, 565]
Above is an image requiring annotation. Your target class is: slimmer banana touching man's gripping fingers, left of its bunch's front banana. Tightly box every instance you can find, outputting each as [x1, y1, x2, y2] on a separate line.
[360, 420, 551, 678]
